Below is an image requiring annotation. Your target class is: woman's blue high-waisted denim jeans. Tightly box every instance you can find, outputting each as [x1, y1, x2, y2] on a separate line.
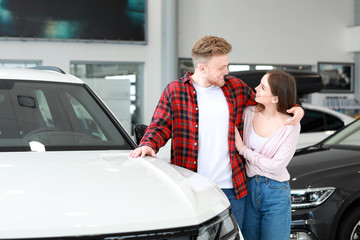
[242, 176, 291, 240]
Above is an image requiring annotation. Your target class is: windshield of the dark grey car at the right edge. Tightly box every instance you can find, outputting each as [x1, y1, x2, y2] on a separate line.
[323, 120, 360, 149]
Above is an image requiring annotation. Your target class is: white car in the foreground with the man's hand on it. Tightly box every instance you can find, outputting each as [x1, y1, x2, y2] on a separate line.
[0, 68, 242, 240]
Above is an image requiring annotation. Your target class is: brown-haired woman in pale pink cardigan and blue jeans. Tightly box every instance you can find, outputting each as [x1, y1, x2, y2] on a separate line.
[235, 71, 300, 240]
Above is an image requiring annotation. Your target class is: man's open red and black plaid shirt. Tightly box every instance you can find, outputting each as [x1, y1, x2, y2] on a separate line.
[139, 73, 256, 199]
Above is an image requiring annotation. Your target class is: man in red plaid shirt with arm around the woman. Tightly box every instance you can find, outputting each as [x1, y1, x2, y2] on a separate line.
[130, 36, 304, 227]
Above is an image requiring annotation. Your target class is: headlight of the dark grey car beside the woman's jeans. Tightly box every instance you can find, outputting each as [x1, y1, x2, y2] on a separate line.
[291, 187, 335, 209]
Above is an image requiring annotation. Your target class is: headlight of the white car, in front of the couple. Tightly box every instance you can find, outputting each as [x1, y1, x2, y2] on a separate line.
[196, 209, 240, 240]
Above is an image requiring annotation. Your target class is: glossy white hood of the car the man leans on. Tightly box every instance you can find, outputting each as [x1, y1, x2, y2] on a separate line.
[0, 151, 229, 238]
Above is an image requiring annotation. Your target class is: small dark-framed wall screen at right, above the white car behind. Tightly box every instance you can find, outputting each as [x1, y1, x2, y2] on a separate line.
[318, 62, 354, 93]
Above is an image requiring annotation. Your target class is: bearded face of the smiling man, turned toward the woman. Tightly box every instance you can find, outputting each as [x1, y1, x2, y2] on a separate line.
[202, 55, 229, 87]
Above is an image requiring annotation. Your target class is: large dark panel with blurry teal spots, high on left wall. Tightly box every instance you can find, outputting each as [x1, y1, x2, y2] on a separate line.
[0, 0, 147, 44]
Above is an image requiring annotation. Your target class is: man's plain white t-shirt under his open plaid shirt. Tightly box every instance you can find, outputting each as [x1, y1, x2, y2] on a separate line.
[193, 83, 233, 188]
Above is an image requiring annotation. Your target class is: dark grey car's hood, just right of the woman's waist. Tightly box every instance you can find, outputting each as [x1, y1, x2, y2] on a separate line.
[287, 147, 360, 188]
